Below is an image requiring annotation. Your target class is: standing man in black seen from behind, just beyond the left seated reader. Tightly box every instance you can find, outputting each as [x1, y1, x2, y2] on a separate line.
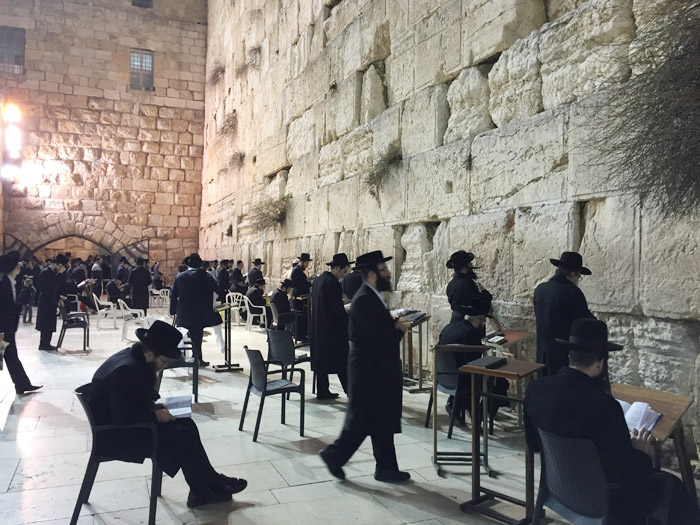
[170, 253, 222, 366]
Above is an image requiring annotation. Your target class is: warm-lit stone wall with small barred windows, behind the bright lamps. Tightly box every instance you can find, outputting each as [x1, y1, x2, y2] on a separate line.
[0, 0, 207, 274]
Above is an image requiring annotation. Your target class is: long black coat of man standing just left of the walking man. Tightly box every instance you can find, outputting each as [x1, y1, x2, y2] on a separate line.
[311, 272, 349, 374]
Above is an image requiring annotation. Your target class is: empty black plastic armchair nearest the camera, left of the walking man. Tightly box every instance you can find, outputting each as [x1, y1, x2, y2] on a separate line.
[238, 346, 304, 441]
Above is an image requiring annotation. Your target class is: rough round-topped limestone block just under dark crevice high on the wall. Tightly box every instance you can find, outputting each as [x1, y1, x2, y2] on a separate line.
[445, 67, 494, 144]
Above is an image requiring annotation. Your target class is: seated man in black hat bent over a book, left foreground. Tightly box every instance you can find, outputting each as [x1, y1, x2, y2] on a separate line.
[88, 321, 248, 507]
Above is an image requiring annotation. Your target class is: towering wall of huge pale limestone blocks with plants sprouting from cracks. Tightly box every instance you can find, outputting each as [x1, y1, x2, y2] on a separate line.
[200, 0, 700, 458]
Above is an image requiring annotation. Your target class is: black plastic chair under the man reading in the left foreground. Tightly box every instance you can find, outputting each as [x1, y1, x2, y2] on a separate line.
[70, 383, 163, 525]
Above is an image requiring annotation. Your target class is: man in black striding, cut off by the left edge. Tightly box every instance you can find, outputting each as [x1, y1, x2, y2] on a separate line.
[0, 252, 41, 394]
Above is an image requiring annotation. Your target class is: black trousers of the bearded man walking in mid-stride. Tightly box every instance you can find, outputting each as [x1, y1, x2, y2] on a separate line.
[323, 425, 399, 472]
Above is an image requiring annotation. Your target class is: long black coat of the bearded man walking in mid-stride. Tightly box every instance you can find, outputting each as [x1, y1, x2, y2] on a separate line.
[345, 284, 403, 434]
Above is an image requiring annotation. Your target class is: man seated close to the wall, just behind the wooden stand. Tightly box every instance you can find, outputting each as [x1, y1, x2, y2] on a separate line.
[438, 290, 508, 425]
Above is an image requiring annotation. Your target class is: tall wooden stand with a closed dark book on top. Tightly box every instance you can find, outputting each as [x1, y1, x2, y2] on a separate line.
[459, 359, 544, 525]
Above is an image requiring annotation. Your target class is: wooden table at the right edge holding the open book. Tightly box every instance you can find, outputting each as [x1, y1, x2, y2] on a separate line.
[611, 383, 698, 504]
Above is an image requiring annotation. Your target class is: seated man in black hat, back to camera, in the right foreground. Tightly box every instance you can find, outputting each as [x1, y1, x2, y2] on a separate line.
[525, 319, 700, 525]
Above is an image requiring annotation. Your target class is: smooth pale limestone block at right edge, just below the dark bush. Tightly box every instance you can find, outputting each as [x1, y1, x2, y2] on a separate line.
[640, 210, 700, 320]
